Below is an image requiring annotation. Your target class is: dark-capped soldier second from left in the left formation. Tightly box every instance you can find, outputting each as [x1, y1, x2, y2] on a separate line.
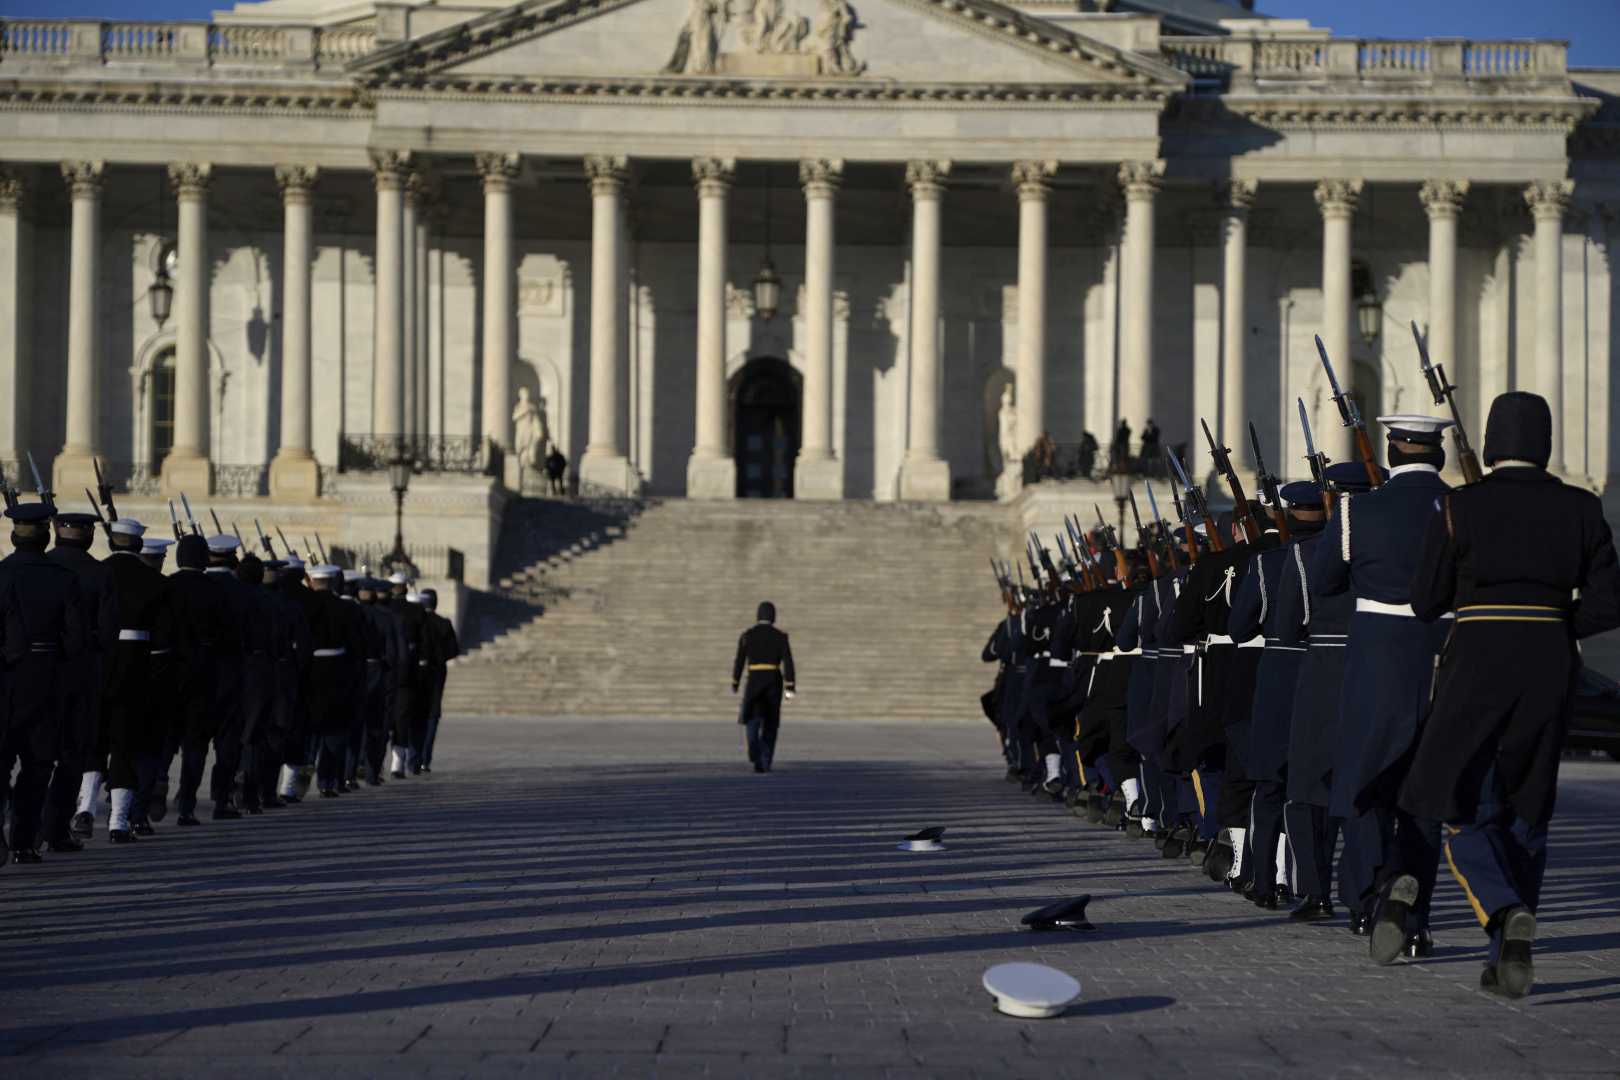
[41, 513, 118, 852]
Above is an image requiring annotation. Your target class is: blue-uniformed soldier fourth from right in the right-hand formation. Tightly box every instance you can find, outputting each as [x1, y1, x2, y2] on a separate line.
[1226, 481, 1325, 908]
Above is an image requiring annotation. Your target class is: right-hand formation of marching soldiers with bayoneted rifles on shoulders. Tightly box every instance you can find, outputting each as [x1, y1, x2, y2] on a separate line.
[983, 327, 1620, 997]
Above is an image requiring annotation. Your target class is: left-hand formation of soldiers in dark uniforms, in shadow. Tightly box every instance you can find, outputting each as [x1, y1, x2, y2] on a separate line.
[0, 470, 460, 863]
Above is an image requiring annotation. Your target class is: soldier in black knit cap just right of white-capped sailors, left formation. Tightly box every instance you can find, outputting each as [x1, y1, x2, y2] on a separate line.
[159, 536, 233, 827]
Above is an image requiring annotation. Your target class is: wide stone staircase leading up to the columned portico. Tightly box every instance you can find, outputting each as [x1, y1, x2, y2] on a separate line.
[444, 499, 1009, 719]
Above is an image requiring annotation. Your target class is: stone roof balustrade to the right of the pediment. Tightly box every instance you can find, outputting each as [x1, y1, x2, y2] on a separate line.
[1160, 37, 1568, 91]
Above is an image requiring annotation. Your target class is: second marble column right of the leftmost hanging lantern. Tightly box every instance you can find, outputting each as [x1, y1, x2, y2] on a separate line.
[271, 165, 321, 502]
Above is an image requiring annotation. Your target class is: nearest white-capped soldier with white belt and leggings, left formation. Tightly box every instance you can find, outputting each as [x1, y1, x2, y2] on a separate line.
[86, 518, 167, 844]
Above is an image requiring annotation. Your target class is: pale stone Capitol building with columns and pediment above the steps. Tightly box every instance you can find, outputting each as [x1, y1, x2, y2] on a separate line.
[0, 0, 1620, 592]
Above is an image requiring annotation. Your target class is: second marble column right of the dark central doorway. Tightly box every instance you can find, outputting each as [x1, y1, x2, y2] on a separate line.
[901, 160, 951, 502]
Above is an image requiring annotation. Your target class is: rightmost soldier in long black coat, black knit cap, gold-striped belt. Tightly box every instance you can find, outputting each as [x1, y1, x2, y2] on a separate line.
[1374, 392, 1620, 997]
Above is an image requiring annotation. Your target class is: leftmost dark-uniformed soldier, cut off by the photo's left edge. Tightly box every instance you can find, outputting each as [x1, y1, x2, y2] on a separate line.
[0, 502, 86, 863]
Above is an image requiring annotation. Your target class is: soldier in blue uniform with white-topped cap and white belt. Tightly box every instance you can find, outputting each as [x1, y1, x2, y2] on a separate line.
[1311, 416, 1452, 962]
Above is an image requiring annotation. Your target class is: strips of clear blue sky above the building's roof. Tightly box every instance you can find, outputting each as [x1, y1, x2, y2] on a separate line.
[9, 0, 1620, 68]
